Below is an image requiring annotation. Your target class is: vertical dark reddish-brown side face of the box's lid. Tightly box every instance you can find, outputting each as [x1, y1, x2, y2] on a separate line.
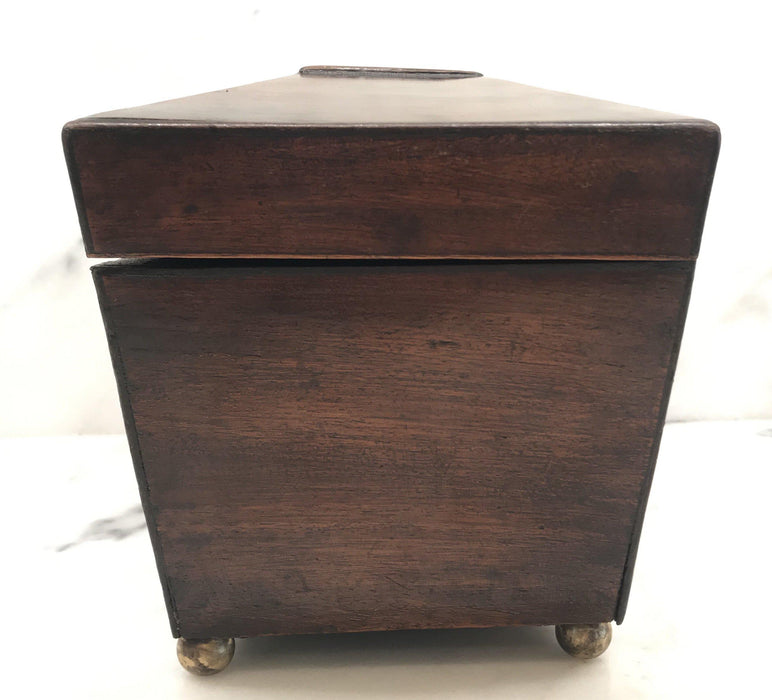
[65, 123, 718, 259]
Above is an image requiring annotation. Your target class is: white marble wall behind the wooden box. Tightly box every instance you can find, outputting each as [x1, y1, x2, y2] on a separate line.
[0, 0, 772, 435]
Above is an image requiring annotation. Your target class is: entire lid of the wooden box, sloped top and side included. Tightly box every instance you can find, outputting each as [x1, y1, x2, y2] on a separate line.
[63, 66, 719, 259]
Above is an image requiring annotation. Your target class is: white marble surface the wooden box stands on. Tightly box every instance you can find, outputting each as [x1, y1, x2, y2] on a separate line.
[0, 421, 772, 700]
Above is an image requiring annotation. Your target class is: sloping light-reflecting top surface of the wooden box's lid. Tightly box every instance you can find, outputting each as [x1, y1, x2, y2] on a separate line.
[80, 66, 693, 126]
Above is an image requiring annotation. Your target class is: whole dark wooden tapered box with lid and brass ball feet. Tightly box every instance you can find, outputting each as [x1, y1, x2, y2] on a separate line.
[63, 66, 719, 673]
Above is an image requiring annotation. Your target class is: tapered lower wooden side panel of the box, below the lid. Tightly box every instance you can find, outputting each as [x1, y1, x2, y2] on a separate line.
[94, 261, 693, 638]
